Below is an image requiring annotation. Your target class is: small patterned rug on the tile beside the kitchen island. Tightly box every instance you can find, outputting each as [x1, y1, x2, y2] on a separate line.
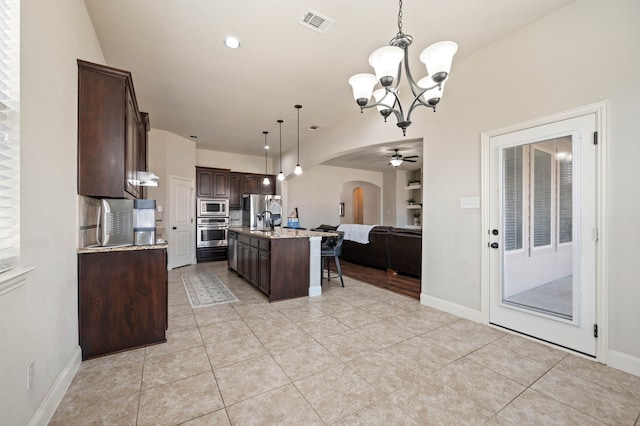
[182, 271, 238, 308]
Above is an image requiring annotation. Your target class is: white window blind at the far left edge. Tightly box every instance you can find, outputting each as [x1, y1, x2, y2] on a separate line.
[0, 0, 20, 270]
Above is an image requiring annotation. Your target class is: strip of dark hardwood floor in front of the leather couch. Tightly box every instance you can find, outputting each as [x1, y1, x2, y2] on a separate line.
[331, 260, 421, 300]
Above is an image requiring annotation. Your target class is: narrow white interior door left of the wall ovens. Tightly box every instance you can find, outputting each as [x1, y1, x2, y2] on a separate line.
[168, 176, 195, 269]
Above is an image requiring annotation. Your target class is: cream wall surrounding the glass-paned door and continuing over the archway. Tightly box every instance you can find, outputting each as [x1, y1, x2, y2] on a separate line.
[291, 0, 640, 366]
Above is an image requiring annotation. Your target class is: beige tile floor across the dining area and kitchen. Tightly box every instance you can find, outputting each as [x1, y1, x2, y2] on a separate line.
[50, 262, 640, 425]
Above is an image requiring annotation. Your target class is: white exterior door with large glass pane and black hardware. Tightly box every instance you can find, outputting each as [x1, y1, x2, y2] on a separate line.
[489, 114, 598, 356]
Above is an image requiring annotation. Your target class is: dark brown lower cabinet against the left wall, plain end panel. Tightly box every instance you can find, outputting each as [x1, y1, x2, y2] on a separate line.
[78, 248, 168, 360]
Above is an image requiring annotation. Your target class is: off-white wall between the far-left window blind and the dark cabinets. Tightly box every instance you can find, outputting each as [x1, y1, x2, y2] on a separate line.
[0, 0, 104, 425]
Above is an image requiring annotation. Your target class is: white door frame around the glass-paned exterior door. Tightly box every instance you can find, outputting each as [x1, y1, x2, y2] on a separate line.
[481, 101, 609, 364]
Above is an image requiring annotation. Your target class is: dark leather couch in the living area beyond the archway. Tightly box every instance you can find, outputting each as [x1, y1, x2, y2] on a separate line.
[318, 225, 422, 278]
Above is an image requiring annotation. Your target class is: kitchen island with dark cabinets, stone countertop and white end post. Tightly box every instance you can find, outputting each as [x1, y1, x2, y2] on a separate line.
[228, 227, 335, 302]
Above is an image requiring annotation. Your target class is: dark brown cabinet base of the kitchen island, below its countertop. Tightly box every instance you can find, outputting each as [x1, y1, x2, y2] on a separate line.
[238, 233, 310, 302]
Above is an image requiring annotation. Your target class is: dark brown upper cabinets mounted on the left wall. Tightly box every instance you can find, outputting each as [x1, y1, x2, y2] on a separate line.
[78, 60, 149, 198]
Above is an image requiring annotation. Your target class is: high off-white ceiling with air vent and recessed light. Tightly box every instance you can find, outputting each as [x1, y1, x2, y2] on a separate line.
[85, 0, 572, 169]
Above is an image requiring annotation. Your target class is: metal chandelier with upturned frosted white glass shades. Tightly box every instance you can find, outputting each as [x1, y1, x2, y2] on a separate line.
[349, 0, 458, 136]
